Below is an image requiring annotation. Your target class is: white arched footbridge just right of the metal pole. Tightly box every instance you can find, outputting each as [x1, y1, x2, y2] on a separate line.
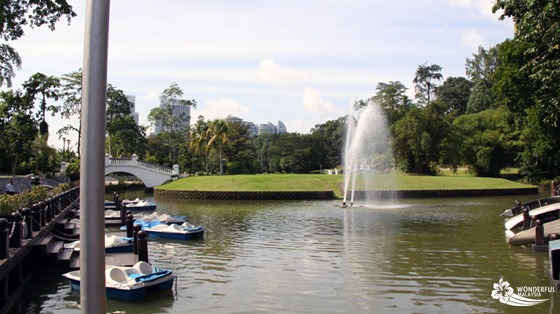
[105, 154, 179, 188]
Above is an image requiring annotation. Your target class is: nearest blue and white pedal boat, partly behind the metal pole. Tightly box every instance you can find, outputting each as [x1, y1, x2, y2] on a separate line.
[62, 262, 177, 302]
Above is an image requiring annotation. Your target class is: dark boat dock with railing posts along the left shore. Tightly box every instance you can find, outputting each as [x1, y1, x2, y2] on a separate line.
[0, 187, 148, 313]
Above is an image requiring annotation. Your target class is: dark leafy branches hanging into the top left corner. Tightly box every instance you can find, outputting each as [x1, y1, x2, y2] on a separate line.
[0, 0, 76, 87]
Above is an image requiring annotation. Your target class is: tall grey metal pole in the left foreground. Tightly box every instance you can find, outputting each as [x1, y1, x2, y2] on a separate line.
[80, 0, 110, 314]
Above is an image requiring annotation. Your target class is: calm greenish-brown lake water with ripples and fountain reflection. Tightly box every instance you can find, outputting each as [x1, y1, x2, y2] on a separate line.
[10, 193, 560, 313]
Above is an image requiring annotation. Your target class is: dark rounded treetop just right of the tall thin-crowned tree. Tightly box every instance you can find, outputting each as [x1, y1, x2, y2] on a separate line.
[436, 77, 473, 115]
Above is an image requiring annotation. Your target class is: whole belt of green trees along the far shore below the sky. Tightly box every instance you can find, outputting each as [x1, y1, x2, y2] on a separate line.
[0, 0, 560, 182]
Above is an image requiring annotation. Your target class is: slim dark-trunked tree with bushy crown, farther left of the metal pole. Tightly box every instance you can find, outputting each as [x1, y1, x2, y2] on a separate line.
[23, 73, 60, 138]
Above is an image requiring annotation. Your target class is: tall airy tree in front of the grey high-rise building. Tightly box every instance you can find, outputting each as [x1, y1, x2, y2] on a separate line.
[148, 83, 196, 162]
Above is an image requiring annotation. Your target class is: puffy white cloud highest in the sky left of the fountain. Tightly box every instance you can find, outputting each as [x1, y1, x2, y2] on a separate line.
[255, 60, 310, 85]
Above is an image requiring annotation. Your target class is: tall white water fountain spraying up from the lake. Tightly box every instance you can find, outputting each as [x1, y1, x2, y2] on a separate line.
[342, 101, 391, 207]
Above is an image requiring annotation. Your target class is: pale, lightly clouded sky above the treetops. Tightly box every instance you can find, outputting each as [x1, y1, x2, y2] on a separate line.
[6, 0, 513, 149]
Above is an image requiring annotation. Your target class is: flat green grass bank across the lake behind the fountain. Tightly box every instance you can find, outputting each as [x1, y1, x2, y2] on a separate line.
[156, 174, 529, 197]
